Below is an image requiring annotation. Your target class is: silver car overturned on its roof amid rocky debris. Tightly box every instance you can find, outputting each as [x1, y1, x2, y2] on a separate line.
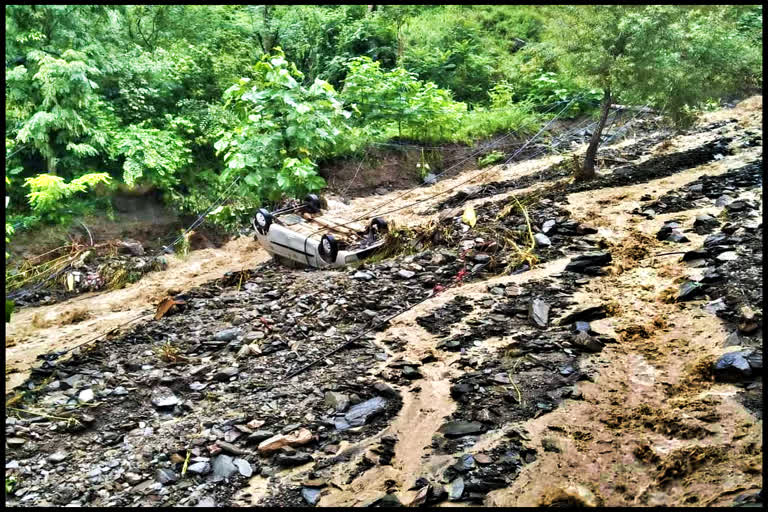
[251, 195, 388, 268]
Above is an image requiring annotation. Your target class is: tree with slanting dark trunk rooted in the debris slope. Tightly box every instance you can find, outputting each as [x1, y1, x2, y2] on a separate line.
[550, 5, 751, 180]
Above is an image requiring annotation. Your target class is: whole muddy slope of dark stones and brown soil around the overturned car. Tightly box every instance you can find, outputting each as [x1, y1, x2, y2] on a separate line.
[6, 97, 762, 506]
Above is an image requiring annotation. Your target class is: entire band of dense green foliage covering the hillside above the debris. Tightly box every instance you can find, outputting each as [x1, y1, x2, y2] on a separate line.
[5, 4, 762, 230]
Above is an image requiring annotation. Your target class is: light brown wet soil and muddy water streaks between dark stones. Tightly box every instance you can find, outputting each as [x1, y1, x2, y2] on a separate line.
[6, 98, 762, 506]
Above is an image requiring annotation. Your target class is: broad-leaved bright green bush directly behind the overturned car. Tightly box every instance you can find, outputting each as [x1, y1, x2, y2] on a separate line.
[215, 48, 350, 201]
